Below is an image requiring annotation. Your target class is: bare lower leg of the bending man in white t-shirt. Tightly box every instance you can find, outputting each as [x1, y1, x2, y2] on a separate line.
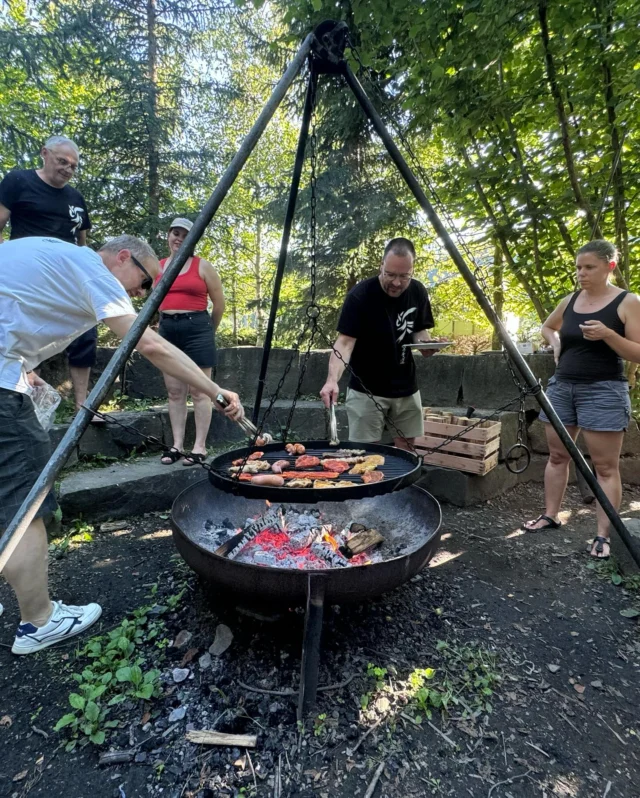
[2, 518, 53, 626]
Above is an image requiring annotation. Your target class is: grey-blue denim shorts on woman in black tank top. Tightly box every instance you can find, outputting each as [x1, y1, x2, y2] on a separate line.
[539, 377, 631, 432]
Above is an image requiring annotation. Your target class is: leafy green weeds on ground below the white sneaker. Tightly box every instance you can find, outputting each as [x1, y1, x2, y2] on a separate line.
[54, 591, 172, 751]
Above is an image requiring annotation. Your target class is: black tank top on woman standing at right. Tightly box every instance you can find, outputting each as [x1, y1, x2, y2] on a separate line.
[555, 291, 629, 382]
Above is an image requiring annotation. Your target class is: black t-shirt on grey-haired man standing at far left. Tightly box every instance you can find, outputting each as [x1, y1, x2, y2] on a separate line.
[0, 169, 91, 244]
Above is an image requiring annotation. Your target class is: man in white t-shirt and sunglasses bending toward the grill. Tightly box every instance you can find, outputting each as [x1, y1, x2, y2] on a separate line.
[0, 235, 243, 654]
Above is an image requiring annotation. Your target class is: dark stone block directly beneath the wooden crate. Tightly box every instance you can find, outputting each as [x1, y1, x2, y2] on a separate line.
[418, 464, 518, 507]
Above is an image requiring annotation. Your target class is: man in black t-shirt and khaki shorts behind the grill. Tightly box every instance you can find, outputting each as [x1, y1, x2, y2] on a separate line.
[320, 238, 434, 449]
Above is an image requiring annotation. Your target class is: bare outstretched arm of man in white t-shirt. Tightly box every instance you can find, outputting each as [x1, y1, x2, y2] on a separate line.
[102, 316, 244, 421]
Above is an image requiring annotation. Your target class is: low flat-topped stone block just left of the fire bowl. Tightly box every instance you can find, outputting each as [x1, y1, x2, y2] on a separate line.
[59, 457, 206, 521]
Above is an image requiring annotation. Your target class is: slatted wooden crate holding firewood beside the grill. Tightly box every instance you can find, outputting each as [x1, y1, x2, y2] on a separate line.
[415, 408, 502, 475]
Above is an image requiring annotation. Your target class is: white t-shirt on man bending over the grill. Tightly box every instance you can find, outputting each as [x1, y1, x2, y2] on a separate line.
[0, 236, 135, 393]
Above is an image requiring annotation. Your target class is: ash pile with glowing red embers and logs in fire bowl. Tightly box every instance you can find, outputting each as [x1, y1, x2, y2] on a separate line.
[207, 506, 384, 570]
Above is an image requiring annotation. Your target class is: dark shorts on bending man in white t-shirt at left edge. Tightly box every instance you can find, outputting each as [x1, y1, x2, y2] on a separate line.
[0, 388, 57, 529]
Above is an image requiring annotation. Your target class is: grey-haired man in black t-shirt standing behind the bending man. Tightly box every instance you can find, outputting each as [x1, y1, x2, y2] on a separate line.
[0, 136, 98, 410]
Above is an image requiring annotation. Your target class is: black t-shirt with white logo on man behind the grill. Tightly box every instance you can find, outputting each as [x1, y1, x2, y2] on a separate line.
[338, 277, 434, 398]
